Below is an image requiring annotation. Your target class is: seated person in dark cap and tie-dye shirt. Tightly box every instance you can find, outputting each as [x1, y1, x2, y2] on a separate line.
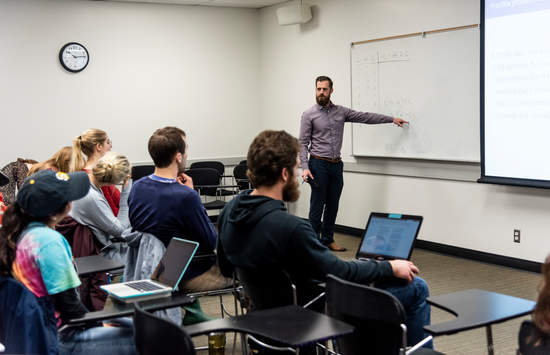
[0, 170, 135, 355]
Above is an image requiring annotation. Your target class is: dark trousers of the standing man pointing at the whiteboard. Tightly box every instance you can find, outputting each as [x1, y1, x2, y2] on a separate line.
[309, 157, 344, 245]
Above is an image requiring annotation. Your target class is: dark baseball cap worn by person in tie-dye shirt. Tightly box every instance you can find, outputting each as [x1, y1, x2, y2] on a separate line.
[17, 170, 90, 217]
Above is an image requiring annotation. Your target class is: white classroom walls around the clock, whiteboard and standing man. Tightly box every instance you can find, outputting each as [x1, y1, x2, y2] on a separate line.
[0, 0, 550, 261]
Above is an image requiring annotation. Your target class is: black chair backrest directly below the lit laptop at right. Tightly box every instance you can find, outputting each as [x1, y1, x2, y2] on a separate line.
[326, 275, 405, 355]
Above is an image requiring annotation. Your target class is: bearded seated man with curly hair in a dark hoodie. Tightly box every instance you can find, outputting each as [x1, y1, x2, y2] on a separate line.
[218, 131, 433, 347]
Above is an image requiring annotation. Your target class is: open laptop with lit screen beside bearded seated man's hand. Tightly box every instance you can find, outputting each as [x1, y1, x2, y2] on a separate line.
[355, 212, 423, 260]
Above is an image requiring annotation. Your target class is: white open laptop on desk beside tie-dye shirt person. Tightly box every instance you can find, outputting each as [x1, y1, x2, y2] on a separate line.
[100, 238, 199, 302]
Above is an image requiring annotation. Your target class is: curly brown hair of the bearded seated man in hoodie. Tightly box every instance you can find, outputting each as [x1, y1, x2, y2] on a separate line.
[246, 131, 300, 187]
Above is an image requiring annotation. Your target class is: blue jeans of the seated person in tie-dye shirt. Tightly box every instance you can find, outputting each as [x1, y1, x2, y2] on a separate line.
[58, 318, 137, 355]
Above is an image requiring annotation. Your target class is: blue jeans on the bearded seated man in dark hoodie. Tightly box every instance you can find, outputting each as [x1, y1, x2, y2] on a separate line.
[375, 277, 433, 349]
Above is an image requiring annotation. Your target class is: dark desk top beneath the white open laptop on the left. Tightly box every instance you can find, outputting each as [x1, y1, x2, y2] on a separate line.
[68, 293, 195, 324]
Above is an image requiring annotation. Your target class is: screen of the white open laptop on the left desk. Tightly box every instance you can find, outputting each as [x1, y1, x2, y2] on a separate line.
[151, 238, 199, 288]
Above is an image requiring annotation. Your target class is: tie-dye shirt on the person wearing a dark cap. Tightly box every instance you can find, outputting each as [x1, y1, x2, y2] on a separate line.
[13, 222, 80, 297]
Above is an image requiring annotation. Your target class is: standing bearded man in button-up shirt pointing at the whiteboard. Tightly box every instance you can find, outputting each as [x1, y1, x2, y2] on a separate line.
[300, 76, 409, 251]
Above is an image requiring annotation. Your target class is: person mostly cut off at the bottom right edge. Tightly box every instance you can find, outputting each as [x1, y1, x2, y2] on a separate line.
[518, 255, 550, 355]
